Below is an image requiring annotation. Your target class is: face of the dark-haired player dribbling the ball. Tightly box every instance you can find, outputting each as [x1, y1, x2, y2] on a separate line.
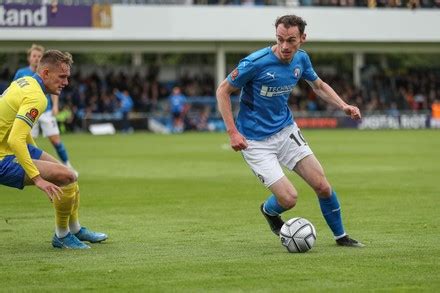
[276, 24, 306, 62]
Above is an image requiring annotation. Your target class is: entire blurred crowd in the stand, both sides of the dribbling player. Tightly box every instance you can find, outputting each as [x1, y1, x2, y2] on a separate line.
[0, 66, 440, 131]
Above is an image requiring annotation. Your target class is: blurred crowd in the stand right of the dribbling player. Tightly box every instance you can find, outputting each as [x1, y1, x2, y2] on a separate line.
[291, 67, 440, 115]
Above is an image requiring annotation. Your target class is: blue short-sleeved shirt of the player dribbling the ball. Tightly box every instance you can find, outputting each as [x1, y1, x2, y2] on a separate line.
[227, 47, 318, 140]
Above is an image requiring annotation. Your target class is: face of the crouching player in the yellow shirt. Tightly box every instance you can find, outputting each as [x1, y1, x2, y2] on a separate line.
[41, 63, 70, 96]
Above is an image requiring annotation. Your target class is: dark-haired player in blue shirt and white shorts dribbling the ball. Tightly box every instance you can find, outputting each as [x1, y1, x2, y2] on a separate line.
[217, 15, 364, 247]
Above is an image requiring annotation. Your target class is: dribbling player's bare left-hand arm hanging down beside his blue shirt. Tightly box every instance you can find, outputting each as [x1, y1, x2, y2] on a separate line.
[216, 79, 248, 151]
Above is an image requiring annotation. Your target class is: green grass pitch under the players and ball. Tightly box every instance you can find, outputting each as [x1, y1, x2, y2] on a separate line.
[0, 130, 440, 292]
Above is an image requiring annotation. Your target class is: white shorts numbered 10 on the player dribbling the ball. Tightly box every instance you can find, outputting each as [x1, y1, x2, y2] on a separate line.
[241, 124, 313, 187]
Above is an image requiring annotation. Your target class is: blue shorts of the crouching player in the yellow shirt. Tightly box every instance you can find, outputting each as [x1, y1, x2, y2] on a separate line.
[0, 144, 43, 189]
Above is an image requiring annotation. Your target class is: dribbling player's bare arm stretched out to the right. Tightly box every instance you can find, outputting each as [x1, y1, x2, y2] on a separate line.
[306, 78, 362, 120]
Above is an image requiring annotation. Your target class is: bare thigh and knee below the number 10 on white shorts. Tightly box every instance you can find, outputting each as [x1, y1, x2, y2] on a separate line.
[294, 154, 330, 195]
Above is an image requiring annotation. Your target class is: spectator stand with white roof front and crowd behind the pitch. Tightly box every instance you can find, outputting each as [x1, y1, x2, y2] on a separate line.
[0, 1, 440, 131]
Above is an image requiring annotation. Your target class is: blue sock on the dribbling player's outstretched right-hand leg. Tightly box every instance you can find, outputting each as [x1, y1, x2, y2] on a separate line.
[318, 190, 345, 238]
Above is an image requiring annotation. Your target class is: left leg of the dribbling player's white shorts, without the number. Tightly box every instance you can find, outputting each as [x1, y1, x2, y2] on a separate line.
[241, 140, 284, 187]
